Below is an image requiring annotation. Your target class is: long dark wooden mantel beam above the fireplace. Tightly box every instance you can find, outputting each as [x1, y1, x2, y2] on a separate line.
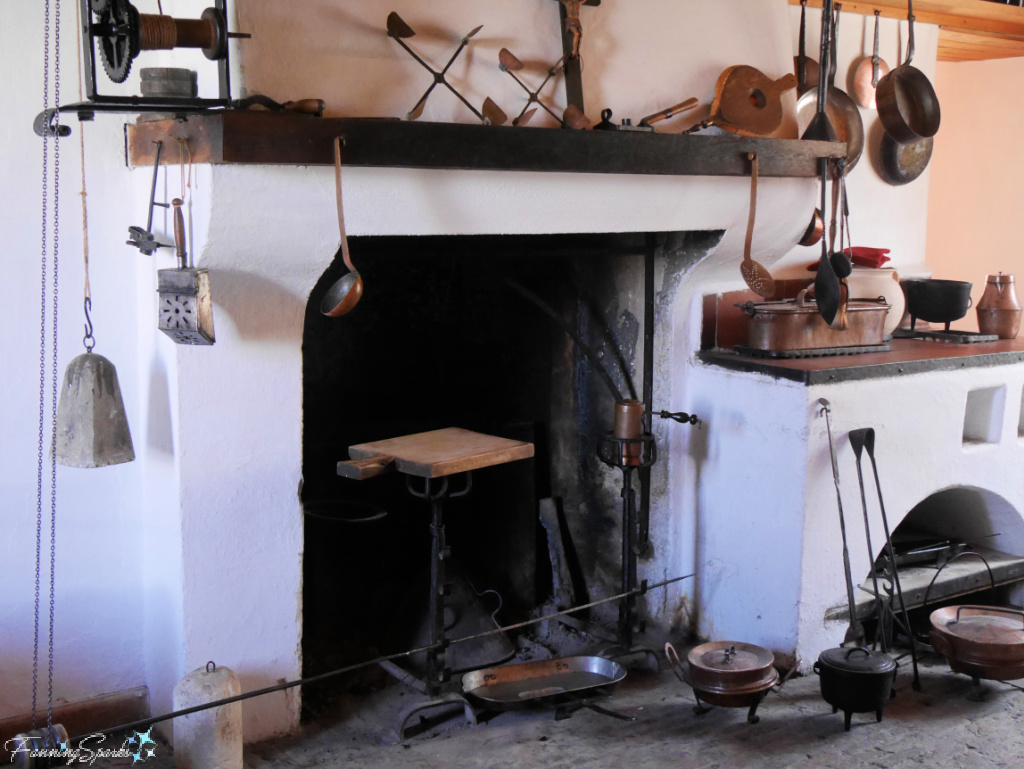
[128, 110, 846, 177]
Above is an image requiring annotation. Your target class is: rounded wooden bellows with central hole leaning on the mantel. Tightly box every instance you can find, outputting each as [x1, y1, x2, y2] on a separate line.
[684, 65, 797, 136]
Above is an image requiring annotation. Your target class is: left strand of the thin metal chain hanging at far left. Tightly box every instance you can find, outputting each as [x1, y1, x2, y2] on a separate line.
[32, 0, 50, 729]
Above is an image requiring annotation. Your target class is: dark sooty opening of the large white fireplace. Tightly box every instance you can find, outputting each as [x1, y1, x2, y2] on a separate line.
[302, 232, 721, 712]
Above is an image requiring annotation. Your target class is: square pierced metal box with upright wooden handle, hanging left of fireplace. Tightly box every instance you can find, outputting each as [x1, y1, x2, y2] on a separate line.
[157, 198, 216, 345]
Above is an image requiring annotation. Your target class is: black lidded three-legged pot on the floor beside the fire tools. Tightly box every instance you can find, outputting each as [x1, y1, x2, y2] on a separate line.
[814, 646, 899, 731]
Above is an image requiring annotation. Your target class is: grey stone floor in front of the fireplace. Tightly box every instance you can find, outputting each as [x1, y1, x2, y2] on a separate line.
[130, 658, 1024, 769]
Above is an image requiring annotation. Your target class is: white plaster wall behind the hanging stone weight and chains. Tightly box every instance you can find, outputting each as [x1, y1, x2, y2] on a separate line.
[0, 3, 147, 718]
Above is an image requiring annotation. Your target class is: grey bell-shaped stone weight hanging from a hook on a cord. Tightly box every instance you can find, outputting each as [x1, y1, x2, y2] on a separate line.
[53, 352, 135, 467]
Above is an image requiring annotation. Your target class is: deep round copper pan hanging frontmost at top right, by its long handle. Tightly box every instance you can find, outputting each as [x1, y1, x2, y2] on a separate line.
[876, 0, 942, 143]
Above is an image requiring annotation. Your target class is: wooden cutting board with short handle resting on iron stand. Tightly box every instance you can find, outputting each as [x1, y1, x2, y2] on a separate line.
[338, 427, 534, 480]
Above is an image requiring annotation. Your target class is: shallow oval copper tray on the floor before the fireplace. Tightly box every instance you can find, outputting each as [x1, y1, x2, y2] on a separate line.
[462, 656, 626, 710]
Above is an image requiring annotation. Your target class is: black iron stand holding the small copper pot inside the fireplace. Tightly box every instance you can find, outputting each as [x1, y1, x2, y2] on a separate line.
[597, 432, 658, 670]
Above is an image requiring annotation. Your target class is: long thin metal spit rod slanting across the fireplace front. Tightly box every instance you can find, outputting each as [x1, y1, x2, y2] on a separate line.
[71, 573, 694, 742]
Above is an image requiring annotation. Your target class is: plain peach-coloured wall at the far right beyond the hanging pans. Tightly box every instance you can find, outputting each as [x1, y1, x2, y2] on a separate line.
[926, 58, 1024, 329]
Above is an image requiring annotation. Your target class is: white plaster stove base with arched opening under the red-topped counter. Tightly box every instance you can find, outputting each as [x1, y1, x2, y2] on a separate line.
[680, 365, 1024, 670]
